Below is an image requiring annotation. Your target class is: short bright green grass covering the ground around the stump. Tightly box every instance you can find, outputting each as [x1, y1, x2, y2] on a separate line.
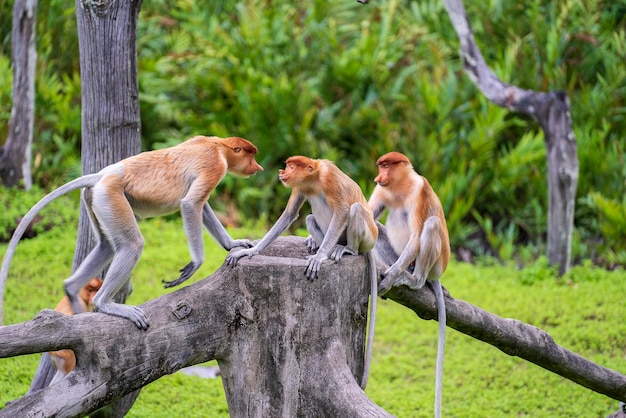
[0, 219, 626, 418]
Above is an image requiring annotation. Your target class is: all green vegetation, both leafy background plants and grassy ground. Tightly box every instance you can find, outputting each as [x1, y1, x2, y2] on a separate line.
[0, 0, 626, 417]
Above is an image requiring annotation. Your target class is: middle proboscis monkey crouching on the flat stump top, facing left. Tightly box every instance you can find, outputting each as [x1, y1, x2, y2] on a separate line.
[226, 156, 378, 388]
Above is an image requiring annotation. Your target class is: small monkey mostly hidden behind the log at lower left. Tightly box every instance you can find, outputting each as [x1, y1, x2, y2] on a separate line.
[48, 277, 102, 384]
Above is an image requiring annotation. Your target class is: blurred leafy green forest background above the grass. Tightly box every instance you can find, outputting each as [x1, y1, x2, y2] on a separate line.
[0, 0, 626, 268]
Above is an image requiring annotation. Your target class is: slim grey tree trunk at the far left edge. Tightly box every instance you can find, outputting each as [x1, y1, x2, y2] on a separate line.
[0, 0, 37, 190]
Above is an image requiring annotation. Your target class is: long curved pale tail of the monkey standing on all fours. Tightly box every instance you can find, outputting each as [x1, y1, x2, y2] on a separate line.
[0, 173, 103, 325]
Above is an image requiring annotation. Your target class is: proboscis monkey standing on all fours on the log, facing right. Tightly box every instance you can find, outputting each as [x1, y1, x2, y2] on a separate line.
[0, 136, 263, 329]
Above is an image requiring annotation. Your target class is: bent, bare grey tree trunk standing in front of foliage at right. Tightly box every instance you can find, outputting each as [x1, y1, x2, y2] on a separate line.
[444, 0, 578, 275]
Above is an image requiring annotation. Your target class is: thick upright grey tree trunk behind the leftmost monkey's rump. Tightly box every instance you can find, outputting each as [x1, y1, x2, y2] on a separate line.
[74, 0, 142, 268]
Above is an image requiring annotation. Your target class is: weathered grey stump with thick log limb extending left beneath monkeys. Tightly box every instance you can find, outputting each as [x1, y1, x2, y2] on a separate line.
[0, 237, 391, 417]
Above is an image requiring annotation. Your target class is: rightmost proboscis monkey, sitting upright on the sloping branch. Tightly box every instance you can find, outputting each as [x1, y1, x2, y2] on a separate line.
[369, 152, 450, 417]
